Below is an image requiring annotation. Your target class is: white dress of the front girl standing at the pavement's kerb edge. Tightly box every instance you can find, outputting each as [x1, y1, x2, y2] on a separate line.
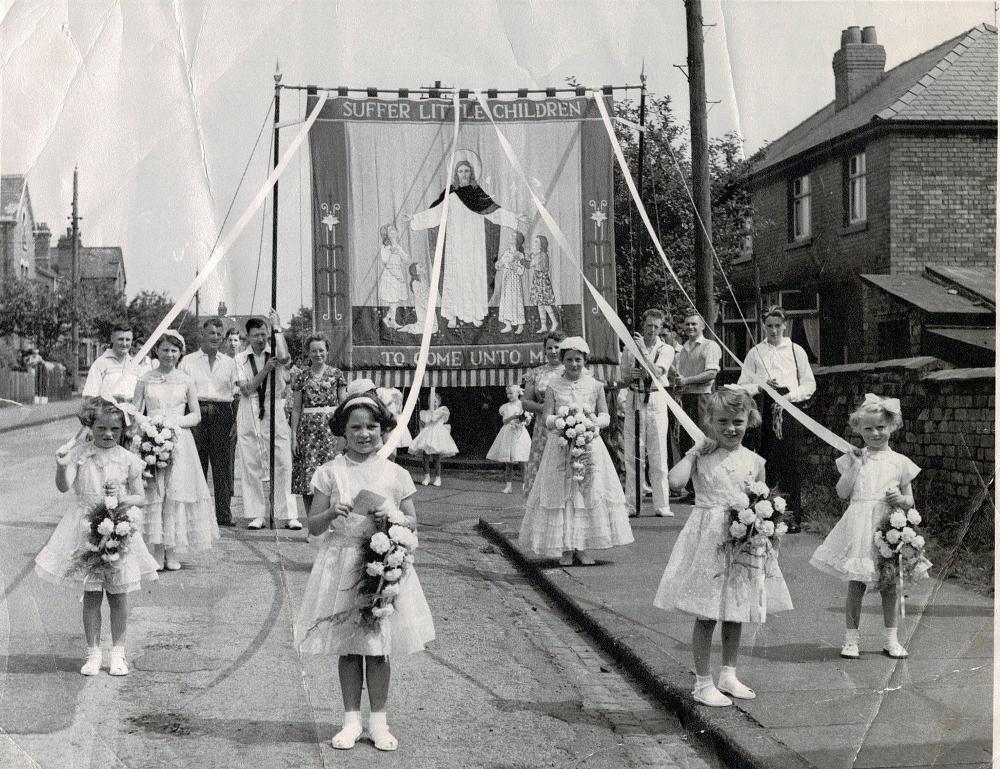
[653, 446, 792, 622]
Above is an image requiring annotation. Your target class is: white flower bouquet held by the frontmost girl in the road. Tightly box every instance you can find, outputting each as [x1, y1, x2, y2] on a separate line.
[354, 492, 417, 630]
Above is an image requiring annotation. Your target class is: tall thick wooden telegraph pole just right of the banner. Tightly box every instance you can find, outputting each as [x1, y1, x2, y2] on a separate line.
[684, 0, 715, 326]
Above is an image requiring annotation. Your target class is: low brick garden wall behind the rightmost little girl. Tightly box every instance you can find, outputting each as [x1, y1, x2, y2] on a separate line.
[800, 357, 996, 543]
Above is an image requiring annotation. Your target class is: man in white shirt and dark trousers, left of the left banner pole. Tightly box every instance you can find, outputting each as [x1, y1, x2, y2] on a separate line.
[178, 318, 236, 526]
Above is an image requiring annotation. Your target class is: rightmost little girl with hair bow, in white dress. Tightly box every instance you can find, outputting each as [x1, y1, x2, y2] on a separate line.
[809, 393, 931, 659]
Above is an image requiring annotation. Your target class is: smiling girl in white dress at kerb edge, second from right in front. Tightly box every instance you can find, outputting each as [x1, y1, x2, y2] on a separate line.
[653, 385, 792, 707]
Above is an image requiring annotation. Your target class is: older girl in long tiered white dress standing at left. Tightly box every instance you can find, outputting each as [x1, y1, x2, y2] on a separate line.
[134, 331, 219, 571]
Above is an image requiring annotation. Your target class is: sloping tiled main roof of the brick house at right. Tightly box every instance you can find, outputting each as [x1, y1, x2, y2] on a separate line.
[753, 24, 997, 173]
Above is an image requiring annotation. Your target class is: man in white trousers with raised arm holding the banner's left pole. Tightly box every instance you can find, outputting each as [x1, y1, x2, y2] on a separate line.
[236, 310, 302, 529]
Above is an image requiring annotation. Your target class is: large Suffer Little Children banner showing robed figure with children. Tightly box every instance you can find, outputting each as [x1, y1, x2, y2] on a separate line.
[307, 95, 618, 386]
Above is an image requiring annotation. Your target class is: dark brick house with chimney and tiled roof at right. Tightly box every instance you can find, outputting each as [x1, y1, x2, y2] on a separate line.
[722, 24, 997, 365]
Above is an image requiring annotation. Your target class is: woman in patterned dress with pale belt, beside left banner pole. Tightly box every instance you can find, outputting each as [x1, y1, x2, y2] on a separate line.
[291, 334, 347, 515]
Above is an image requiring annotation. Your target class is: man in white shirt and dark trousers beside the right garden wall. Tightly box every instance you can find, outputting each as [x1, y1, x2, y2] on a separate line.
[739, 307, 816, 533]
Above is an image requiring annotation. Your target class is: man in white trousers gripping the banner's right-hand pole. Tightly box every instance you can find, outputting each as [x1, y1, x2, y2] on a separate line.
[622, 308, 674, 516]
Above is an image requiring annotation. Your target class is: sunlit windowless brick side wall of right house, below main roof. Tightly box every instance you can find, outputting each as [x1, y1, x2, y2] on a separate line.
[889, 133, 997, 273]
